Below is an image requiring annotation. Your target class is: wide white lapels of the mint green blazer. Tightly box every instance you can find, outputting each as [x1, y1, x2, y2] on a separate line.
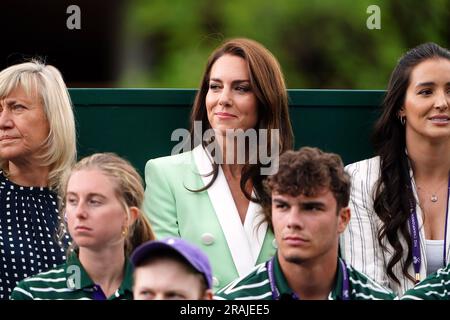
[193, 145, 267, 277]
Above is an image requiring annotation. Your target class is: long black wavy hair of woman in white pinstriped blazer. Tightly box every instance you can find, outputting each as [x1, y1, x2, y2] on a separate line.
[372, 43, 450, 283]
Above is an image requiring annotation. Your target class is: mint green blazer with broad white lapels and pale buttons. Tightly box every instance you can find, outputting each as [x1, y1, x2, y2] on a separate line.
[143, 146, 276, 291]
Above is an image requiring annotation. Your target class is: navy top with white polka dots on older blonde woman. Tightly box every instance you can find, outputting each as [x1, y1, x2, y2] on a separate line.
[0, 171, 65, 299]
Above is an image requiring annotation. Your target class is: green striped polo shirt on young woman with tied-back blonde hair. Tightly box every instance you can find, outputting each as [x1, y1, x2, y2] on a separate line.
[11, 254, 133, 300]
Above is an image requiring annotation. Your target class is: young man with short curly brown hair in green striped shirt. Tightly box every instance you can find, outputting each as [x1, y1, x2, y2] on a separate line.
[215, 147, 395, 300]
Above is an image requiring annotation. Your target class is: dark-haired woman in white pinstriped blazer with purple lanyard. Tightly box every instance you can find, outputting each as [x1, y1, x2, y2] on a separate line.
[342, 43, 450, 295]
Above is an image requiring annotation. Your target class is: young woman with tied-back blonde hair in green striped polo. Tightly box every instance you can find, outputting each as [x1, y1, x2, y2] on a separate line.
[11, 153, 154, 300]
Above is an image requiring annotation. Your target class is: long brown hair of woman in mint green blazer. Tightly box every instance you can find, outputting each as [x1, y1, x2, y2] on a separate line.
[191, 38, 294, 203]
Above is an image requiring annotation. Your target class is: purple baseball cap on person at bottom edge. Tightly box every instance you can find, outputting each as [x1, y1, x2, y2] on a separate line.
[130, 237, 212, 289]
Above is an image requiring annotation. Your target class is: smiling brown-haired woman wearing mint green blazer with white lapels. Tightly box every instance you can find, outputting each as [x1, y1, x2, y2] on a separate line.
[144, 39, 293, 291]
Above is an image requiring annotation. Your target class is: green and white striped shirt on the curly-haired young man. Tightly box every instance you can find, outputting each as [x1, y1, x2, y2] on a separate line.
[214, 254, 395, 300]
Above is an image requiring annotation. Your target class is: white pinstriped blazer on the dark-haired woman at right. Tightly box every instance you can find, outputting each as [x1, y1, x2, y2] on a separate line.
[341, 157, 450, 296]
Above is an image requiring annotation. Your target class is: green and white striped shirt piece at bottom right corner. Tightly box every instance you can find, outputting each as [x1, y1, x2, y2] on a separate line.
[401, 264, 450, 300]
